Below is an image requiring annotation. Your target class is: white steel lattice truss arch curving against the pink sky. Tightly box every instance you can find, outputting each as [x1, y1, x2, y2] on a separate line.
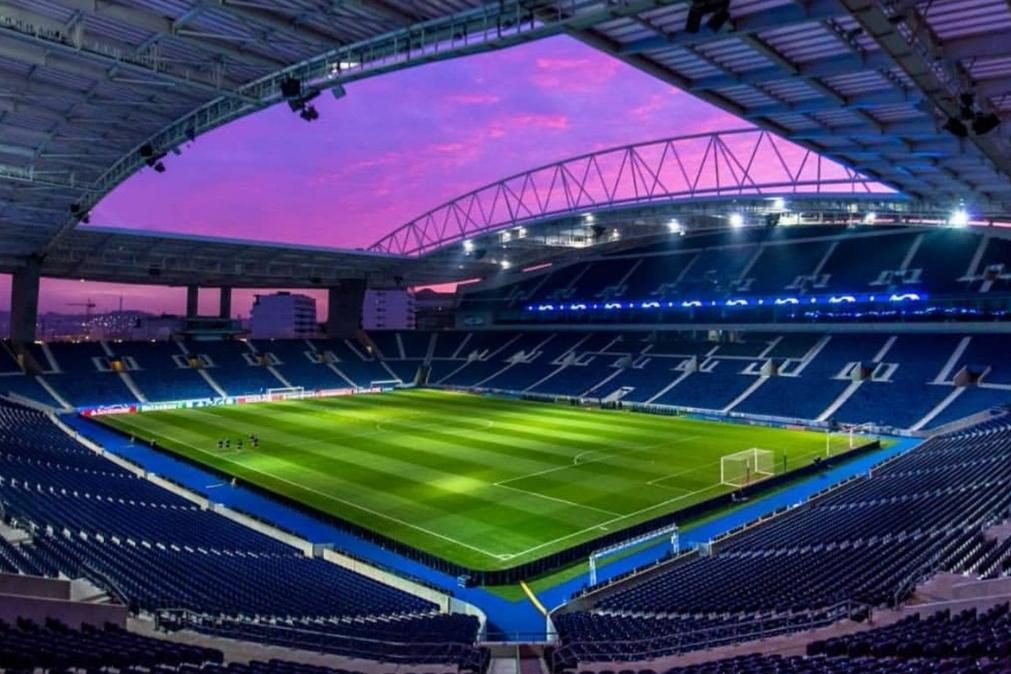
[369, 128, 894, 255]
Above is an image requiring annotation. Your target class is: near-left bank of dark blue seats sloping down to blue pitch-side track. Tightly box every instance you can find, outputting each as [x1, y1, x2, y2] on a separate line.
[0, 404, 477, 662]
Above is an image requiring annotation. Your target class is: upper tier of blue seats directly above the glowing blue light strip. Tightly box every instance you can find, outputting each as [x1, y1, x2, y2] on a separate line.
[497, 226, 986, 311]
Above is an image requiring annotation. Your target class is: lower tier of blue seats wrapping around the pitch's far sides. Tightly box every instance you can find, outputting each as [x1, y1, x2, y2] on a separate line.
[0, 329, 1011, 429]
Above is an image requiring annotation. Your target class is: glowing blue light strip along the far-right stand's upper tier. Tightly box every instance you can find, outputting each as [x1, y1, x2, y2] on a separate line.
[526, 292, 927, 312]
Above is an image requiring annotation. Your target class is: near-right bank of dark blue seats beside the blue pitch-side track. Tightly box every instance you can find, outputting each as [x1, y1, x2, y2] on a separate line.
[555, 418, 1011, 666]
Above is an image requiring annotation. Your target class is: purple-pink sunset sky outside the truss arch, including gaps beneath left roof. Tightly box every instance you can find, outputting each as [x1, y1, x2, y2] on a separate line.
[7, 37, 745, 314]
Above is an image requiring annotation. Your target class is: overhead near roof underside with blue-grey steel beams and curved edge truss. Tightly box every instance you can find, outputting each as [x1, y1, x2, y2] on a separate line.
[0, 0, 1011, 279]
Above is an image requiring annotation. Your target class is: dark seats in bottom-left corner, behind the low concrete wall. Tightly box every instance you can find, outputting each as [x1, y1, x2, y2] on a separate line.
[0, 620, 223, 671]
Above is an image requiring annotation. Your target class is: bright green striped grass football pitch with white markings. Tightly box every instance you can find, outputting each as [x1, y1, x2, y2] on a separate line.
[102, 390, 847, 570]
